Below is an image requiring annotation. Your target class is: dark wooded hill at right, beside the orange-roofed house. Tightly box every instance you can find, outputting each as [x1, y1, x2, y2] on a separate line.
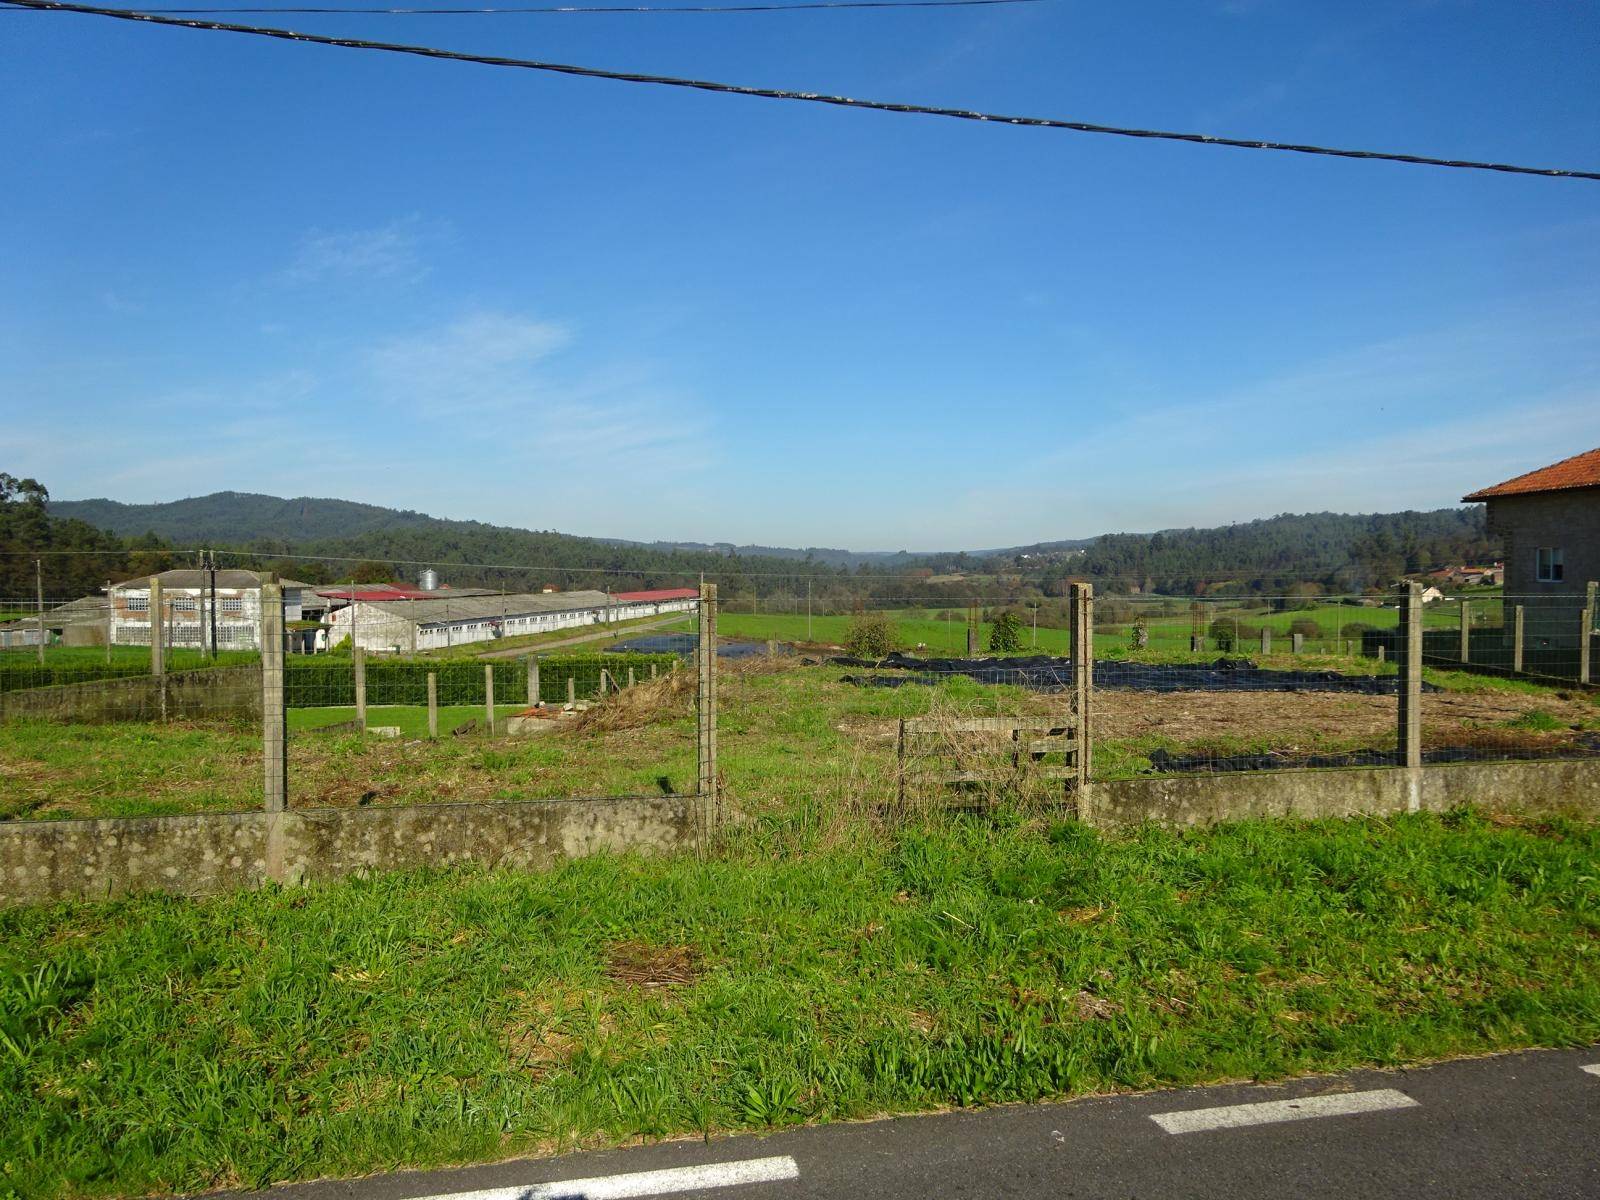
[1072, 507, 1501, 595]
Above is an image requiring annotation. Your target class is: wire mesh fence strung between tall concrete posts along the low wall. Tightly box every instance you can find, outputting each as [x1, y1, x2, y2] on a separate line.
[0, 568, 1600, 818]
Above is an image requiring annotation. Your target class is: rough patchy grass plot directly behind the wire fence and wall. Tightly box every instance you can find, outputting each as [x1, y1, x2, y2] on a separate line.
[0, 653, 1600, 819]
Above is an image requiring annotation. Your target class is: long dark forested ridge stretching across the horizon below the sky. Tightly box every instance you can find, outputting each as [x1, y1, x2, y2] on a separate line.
[37, 488, 1499, 606]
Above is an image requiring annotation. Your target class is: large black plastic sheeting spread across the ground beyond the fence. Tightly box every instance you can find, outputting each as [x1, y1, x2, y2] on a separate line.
[829, 653, 1440, 696]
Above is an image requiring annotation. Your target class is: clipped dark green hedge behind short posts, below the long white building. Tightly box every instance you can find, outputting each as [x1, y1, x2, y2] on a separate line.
[283, 654, 683, 709]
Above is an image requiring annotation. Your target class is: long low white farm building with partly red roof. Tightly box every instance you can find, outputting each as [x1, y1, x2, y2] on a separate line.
[326, 587, 698, 654]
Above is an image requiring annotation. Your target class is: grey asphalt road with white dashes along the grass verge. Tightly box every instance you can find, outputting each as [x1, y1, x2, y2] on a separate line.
[228, 1048, 1600, 1200]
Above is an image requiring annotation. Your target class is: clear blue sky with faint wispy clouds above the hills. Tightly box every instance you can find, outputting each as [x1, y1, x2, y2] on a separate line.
[0, 0, 1600, 549]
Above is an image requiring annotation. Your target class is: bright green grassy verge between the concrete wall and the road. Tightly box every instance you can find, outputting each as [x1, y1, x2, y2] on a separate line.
[0, 811, 1600, 1197]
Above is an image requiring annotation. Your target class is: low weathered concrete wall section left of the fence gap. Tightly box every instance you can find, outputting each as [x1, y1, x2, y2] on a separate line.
[0, 795, 701, 904]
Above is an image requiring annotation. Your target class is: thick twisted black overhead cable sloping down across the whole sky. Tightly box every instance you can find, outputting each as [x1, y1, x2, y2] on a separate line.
[0, 0, 1600, 182]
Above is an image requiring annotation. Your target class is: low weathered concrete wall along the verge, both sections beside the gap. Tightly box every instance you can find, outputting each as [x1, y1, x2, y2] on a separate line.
[0, 760, 1600, 904]
